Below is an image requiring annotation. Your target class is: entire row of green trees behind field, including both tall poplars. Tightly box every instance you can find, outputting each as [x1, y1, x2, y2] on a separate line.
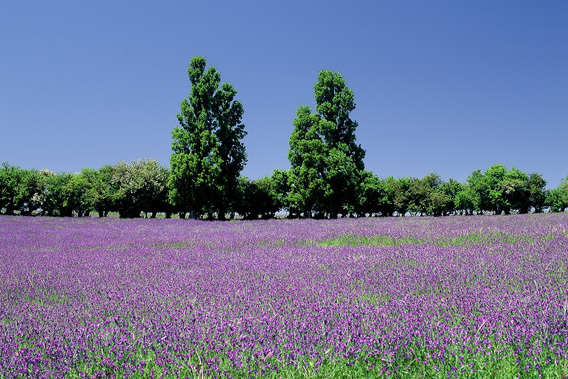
[0, 56, 568, 220]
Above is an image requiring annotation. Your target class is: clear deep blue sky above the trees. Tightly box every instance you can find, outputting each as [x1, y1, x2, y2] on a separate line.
[0, 0, 568, 188]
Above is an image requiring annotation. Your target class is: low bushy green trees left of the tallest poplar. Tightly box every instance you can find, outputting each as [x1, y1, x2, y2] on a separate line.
[0, 160, 170, 217]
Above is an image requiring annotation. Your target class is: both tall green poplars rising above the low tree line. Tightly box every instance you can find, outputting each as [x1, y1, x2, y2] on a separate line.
[169, 56, 365, 219]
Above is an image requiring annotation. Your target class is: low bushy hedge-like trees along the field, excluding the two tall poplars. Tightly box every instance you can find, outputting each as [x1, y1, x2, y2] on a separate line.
[0, 160, 568, 220]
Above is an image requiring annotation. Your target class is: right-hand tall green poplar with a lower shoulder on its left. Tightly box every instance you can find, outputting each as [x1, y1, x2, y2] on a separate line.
[288, 70, 365, 218]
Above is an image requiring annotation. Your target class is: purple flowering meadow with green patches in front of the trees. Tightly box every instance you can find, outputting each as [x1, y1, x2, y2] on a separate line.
[0, 214, 568, 378]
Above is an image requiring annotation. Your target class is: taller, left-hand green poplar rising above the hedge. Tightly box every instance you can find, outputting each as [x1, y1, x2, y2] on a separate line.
[169, 56, 247, 219]
